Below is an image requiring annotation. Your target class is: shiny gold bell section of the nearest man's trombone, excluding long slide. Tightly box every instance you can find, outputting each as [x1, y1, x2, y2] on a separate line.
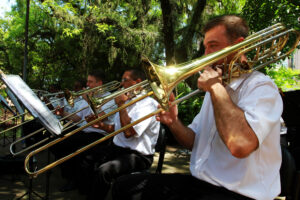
[143, 23, 300, 109]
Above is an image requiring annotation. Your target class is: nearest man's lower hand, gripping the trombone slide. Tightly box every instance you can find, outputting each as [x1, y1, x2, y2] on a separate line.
[156, 93, 178, 126]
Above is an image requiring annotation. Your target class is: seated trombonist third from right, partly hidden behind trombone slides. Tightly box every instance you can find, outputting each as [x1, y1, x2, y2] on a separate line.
[51, 72, 115, 192]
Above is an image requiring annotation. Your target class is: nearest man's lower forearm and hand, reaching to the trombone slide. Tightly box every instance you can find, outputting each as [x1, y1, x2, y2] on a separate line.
[156, 94, 195, 150]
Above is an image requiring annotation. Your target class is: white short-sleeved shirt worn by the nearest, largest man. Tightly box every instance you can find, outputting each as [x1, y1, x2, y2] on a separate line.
[189, 72, 283, 200]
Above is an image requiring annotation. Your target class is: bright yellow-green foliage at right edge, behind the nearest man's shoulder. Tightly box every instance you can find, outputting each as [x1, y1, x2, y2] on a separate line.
[266, 66, 300, 91]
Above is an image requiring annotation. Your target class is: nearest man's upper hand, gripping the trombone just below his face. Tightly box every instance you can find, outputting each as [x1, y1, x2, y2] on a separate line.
[198, 67, 222, 92]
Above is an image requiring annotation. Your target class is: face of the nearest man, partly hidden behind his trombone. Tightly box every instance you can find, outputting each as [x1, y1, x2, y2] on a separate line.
[204, 25, 232, 65]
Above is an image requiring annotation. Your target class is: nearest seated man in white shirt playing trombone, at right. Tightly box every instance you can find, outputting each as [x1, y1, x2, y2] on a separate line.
[112, 15, 282, 200]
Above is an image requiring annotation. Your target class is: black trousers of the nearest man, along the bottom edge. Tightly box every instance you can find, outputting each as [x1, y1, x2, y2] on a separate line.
[112, 174, 254, 200]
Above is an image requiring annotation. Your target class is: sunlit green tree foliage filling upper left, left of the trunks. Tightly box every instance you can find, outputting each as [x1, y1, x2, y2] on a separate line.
[0, 0, 163, 89]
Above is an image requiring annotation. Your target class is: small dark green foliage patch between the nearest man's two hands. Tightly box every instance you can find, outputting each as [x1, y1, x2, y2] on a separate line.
[176, 82, 203, 125]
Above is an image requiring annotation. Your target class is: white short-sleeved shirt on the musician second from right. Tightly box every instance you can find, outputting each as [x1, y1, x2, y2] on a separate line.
[113, 97, 160, 155]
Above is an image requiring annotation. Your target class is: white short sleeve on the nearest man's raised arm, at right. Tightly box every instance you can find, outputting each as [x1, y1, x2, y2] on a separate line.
[237, 77, 283, 144]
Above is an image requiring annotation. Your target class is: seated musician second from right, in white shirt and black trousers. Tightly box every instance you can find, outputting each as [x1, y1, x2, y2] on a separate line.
[78, 69, 160, 199]
